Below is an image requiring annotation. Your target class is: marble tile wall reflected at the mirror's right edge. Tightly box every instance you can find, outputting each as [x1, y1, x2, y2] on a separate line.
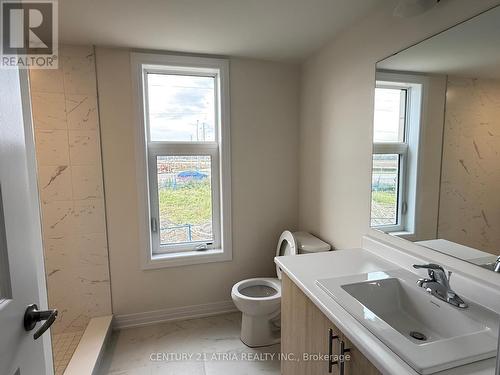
[438, 77, 500, 255]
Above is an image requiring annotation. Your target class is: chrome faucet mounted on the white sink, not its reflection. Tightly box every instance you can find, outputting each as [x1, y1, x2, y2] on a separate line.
[413, 263, 468, 309]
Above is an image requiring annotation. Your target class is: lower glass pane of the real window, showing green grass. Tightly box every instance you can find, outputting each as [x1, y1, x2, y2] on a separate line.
[156, 156, 214, 245]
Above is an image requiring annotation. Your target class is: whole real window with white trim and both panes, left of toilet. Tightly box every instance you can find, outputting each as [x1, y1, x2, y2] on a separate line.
[132, 54, 231, 268]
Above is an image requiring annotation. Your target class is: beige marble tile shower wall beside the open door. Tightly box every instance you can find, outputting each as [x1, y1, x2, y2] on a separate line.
[30, 46, 111, 333]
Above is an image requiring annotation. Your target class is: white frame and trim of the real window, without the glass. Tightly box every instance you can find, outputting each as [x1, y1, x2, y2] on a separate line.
[131, 53, 232, 269]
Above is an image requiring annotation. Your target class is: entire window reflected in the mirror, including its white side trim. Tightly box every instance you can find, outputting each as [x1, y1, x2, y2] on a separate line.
[370, 71, 429, 238]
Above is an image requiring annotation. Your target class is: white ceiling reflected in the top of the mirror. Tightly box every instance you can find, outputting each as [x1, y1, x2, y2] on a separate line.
[377, 7, 500, 79]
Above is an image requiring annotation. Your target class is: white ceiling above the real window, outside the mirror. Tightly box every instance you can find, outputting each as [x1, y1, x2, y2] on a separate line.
[59, 0, 381, 61]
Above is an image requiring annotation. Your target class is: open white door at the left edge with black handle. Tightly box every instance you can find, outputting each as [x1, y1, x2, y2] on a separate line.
[0, 69, 53, 375]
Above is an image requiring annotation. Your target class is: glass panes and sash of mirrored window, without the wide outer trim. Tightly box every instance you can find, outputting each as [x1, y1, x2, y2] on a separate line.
[371, 84, 411, 231]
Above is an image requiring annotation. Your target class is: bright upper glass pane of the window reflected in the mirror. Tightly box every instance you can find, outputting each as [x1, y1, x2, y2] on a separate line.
[373, 88, 406, 142]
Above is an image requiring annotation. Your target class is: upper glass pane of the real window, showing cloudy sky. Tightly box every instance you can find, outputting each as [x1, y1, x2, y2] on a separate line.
[148, 73, 215, 142]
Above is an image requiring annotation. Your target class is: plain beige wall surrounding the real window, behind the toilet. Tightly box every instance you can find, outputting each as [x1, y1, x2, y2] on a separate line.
[97, 48, 299, 315]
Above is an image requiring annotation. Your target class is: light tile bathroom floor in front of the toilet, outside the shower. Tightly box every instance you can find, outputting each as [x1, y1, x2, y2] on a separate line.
[100, 313, 280, 375]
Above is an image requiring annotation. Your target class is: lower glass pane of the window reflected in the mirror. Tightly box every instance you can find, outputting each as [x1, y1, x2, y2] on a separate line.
[371, 154, 400, 227]
